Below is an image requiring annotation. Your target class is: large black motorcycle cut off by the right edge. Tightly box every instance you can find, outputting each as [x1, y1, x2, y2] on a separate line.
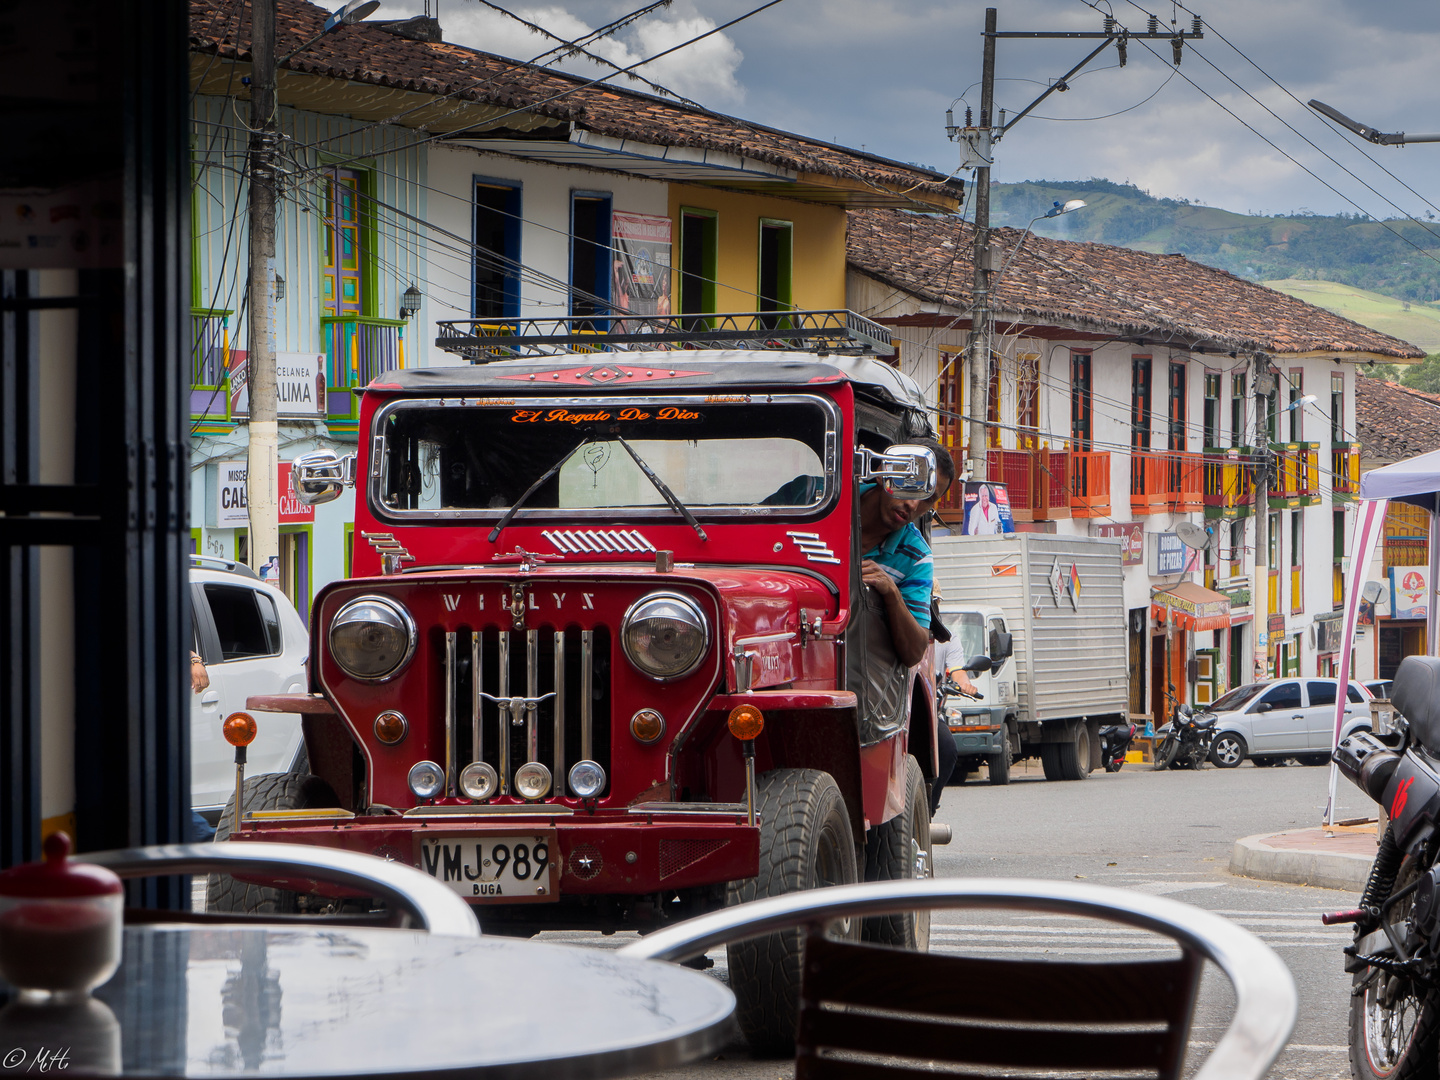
[1320, 657, 1440, 1080]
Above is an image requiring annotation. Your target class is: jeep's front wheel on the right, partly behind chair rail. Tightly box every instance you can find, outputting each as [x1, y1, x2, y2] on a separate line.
[726, 769, 858, 1054]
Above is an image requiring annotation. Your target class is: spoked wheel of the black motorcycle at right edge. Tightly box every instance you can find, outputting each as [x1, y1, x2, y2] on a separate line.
[1349, 860, 1440, 1080]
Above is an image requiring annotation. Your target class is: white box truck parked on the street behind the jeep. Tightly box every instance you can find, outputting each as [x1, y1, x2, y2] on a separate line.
[932, 533, 1130, 783]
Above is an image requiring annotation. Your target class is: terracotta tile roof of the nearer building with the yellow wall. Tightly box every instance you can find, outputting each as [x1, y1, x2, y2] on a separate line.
[190, 0, 959, 207]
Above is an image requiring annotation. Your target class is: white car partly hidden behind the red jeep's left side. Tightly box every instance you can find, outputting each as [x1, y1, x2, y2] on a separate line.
[190, 556, 310, 824]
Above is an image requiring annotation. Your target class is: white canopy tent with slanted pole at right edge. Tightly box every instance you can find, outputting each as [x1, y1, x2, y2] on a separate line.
[1325, 451, 1440, 825]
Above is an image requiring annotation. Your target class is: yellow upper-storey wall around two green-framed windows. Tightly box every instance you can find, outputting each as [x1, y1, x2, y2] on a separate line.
[670, 184, 845, 312]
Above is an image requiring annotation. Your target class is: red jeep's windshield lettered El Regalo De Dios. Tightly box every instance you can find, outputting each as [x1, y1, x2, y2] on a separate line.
[372, 395, 835, 518]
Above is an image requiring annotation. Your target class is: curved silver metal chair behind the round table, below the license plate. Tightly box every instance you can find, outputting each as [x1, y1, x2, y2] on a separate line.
[75, 842, 480, 937]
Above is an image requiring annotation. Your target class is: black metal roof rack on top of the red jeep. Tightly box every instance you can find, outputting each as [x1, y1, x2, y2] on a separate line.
[435, 308, 894, 364]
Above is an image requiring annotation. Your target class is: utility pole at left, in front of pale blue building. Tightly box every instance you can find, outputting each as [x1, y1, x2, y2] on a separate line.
[245, 0, 279, 573]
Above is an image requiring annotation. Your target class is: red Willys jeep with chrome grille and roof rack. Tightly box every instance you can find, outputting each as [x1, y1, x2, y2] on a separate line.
[210, 311, 936, 1045]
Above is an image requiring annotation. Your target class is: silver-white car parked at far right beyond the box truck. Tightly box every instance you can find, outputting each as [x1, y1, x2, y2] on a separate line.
[1210, 678, 1371, 769]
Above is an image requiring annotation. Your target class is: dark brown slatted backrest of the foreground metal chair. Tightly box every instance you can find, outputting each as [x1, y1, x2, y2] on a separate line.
[795, 929, 1201, 1080]
